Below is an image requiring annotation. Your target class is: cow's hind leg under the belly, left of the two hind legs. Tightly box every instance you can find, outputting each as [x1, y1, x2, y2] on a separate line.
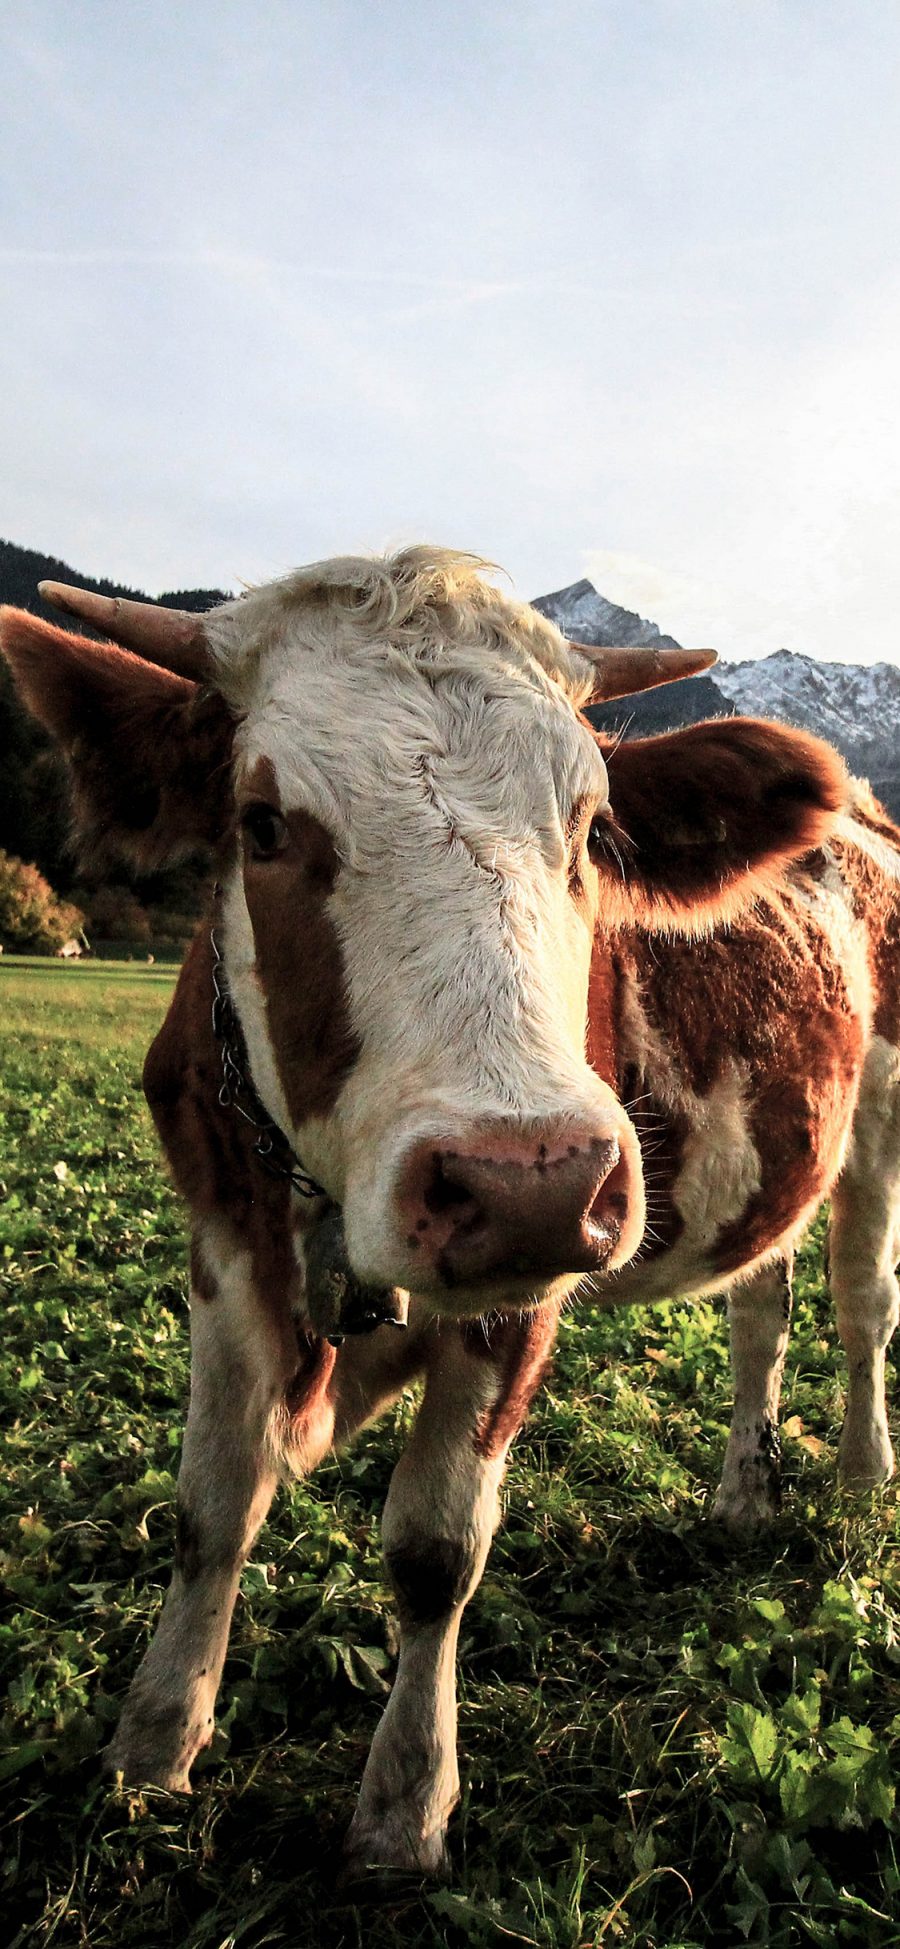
[713, 1253, 793, 1530]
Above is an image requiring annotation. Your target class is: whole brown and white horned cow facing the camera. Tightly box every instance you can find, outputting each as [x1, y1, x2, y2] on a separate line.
[2, 550, 900, 1871]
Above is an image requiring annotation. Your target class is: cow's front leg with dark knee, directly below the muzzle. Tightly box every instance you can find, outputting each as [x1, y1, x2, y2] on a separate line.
[347, 1308, 557, 1881]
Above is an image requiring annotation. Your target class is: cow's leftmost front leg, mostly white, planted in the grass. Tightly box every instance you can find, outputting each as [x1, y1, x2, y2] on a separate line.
[107, 1228, 300, 1793]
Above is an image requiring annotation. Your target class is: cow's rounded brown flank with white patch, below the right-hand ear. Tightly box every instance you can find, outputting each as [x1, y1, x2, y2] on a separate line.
[592, 888, 871, 1298]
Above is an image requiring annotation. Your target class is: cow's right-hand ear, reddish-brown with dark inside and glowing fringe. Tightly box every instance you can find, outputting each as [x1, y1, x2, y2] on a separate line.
[594, 717, 847, 934]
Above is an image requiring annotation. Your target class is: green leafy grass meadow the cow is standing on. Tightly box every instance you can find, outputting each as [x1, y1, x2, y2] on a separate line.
[0, 963, 900, 1949]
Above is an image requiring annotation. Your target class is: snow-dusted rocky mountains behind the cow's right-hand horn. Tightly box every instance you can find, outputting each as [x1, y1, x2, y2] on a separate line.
[534, 581, 900, 819]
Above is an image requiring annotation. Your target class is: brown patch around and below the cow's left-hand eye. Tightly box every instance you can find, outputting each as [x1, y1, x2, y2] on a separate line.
[244, 791, 358, 1125]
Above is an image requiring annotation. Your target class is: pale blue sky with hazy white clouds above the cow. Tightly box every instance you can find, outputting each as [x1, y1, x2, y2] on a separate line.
[0, 0, 900, 663]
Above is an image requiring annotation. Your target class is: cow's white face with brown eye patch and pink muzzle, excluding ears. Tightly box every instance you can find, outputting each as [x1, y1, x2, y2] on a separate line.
[210, 563, 645, 1314]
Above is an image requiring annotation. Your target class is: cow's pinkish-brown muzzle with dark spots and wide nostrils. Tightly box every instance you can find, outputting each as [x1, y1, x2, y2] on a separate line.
[397, 1123, 643, 1290]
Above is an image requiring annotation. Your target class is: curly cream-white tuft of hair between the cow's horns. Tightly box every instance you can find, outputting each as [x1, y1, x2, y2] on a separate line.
[206, 548, 590, 711]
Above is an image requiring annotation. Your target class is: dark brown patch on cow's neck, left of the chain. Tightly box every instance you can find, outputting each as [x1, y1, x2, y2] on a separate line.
[144, 922, 302, 1360]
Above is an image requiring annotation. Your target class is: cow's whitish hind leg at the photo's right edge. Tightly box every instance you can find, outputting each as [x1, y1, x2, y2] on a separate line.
[830, 1037, 900, 1489]
